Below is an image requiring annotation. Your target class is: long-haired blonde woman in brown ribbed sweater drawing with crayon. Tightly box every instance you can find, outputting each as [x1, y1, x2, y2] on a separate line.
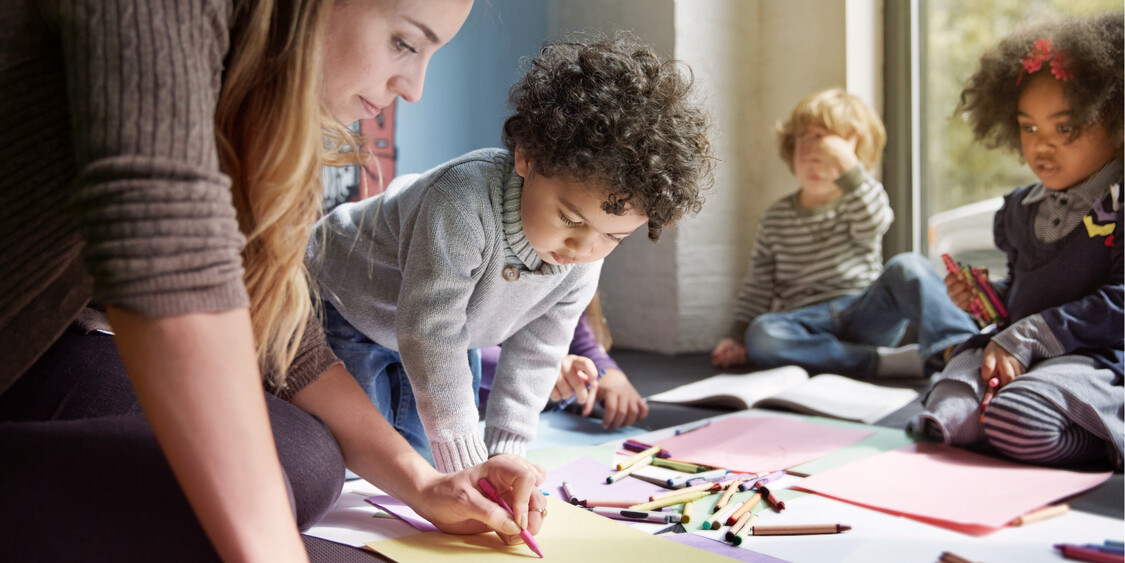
[0, 0, 545, 561]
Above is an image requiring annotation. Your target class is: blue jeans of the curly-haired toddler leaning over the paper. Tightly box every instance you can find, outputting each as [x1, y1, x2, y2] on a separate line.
[324, 302, 480, 465]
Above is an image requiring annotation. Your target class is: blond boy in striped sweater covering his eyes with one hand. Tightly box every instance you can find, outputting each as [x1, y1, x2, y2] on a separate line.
[711, 88, 977, 377]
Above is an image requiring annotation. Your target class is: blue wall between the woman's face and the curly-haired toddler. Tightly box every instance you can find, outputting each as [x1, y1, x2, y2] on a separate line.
[395, 0, 547, 175]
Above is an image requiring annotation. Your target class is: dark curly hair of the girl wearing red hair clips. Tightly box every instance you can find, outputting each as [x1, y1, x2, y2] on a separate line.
[954, 11, 1125, 153]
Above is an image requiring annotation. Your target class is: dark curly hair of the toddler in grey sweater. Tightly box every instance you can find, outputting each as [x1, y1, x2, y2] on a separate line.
[503, 33, 714, 241]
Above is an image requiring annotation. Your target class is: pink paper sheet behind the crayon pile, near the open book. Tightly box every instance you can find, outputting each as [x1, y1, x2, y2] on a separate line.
[657, 417, 874, 473]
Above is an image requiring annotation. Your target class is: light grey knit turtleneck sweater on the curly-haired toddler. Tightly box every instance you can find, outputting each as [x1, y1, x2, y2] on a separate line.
[308, 149, 602, 472]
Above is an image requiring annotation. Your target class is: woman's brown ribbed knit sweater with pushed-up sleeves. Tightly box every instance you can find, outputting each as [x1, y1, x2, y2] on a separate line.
[0, 0, 339, 397]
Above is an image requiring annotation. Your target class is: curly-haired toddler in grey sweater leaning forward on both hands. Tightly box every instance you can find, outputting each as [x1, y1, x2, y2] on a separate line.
[308, 34, 713, 471]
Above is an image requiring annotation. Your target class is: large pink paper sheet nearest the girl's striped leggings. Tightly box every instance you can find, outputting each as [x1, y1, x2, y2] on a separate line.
[795, 444, 1110, 534]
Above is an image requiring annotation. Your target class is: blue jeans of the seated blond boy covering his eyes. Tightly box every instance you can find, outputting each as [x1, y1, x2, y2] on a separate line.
[745, 252, 979, 377]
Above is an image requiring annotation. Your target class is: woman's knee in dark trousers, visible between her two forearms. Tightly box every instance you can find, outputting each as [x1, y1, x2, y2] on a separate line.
[269, 395, 344, 529]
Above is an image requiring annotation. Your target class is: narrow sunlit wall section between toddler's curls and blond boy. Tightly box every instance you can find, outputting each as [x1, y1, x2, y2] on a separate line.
[670, 0, 764, 351]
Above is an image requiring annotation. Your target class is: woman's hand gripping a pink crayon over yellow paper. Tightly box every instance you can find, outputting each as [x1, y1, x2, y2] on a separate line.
[418, 454, 547, 544]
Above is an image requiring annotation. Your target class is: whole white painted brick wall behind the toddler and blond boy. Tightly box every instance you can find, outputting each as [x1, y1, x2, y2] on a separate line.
[548, 0, 868, 354]
